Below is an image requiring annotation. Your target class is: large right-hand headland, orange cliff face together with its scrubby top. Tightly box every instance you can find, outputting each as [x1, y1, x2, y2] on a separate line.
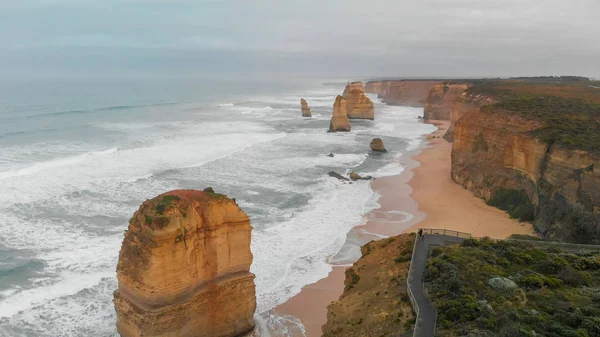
[452, 79, 600, 244]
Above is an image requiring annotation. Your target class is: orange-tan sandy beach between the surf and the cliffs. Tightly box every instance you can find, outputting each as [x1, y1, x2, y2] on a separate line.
[275, 121, 532, 337]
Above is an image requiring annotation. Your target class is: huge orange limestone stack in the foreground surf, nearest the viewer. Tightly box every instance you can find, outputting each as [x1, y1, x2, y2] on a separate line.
[114, 190, 256, 337]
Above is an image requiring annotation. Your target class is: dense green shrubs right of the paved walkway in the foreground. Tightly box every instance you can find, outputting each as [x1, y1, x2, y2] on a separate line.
[425, 240, 600, 337]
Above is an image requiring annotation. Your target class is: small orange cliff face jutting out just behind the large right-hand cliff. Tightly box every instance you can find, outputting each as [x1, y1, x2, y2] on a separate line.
[423, 83, 469, 120]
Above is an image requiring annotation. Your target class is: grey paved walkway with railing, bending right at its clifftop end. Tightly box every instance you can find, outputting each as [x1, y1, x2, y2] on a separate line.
[408, 234, 465, 337]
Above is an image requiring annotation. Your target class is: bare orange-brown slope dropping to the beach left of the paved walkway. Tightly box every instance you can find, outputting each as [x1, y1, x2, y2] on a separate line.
[322, 233, 415, 337]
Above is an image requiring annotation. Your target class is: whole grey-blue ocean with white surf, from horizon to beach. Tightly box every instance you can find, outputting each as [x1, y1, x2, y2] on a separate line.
[0, 79, 434, 337]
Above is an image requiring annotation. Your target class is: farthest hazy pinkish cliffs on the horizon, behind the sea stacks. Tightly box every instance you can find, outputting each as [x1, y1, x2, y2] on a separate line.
[365, 80, 439, 107]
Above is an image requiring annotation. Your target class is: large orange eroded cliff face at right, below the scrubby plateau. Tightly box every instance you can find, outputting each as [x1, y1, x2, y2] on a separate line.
[452, 94, 600, 243]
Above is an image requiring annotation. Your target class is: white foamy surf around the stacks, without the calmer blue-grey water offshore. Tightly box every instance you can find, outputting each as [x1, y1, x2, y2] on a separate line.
[0, 79, 436, 337]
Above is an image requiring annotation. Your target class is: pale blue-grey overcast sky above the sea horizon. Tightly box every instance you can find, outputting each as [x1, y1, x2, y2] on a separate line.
[0, 0, 600, 77]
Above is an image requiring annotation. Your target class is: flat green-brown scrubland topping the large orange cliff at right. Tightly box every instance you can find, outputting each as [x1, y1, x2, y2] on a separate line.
[468, 77, 600, 155]
